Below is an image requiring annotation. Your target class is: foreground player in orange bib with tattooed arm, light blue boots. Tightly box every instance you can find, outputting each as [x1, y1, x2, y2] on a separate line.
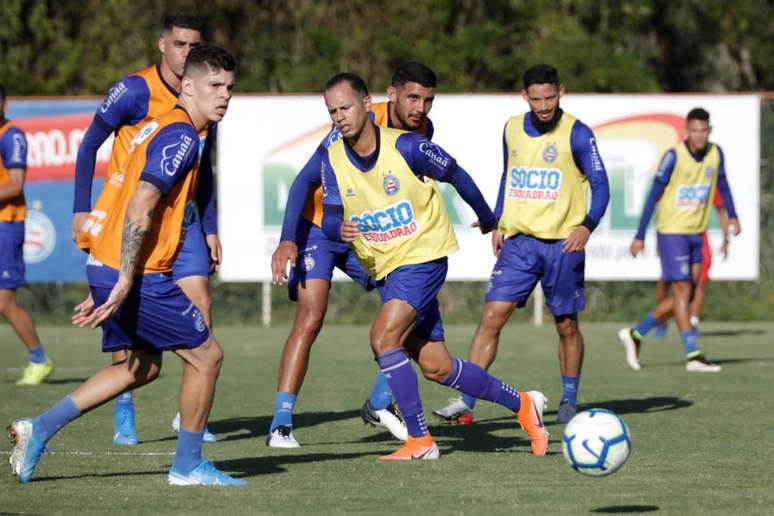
[9, 46, 246, 486]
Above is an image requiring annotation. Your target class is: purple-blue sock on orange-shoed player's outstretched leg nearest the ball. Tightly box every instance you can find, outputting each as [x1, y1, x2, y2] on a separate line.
[440, 357, 521, 412]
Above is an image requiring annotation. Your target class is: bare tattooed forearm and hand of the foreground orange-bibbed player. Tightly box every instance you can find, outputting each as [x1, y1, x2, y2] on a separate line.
[78, 180, 161, 328]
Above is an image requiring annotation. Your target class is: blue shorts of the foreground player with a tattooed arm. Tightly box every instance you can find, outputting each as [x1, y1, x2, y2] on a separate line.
[86, 257, 210, 353]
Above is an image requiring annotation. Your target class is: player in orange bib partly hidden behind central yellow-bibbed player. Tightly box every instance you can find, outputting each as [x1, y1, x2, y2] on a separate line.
[266, 62, 437, 448]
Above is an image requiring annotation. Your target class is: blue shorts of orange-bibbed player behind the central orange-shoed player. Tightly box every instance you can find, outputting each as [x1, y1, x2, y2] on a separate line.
[288, 221, 376, 301]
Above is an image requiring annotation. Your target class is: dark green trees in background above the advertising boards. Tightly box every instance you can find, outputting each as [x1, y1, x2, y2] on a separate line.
[0, 0, 774, 95]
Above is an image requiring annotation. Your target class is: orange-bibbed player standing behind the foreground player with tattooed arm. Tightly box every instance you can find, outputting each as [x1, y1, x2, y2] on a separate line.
[72, 13, 221, 445]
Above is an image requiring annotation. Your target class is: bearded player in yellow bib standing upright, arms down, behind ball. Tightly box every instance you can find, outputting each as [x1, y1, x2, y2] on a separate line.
[434, 64, 610, 424]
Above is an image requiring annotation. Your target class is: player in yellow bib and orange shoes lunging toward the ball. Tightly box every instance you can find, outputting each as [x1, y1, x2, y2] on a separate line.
[322, 73, 548, 460]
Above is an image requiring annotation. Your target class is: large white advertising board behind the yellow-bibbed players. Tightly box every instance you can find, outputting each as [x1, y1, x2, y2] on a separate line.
[218, 94, 760, 281]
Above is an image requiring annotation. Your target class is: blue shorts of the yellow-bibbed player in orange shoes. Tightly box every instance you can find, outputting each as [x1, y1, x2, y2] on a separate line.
[377, 257, 449, 342]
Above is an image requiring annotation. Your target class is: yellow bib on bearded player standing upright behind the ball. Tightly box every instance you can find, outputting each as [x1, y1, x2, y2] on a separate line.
[498, 113, 588, 239]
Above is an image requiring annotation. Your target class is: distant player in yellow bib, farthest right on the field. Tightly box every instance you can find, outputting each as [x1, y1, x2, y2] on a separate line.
[618, 108, 741, 373]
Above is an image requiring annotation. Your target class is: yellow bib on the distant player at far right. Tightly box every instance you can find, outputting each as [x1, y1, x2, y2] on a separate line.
[656, 143, 720, 234]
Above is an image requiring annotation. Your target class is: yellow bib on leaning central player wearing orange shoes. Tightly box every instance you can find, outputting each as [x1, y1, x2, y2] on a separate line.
[328, 127, 458, 280]
